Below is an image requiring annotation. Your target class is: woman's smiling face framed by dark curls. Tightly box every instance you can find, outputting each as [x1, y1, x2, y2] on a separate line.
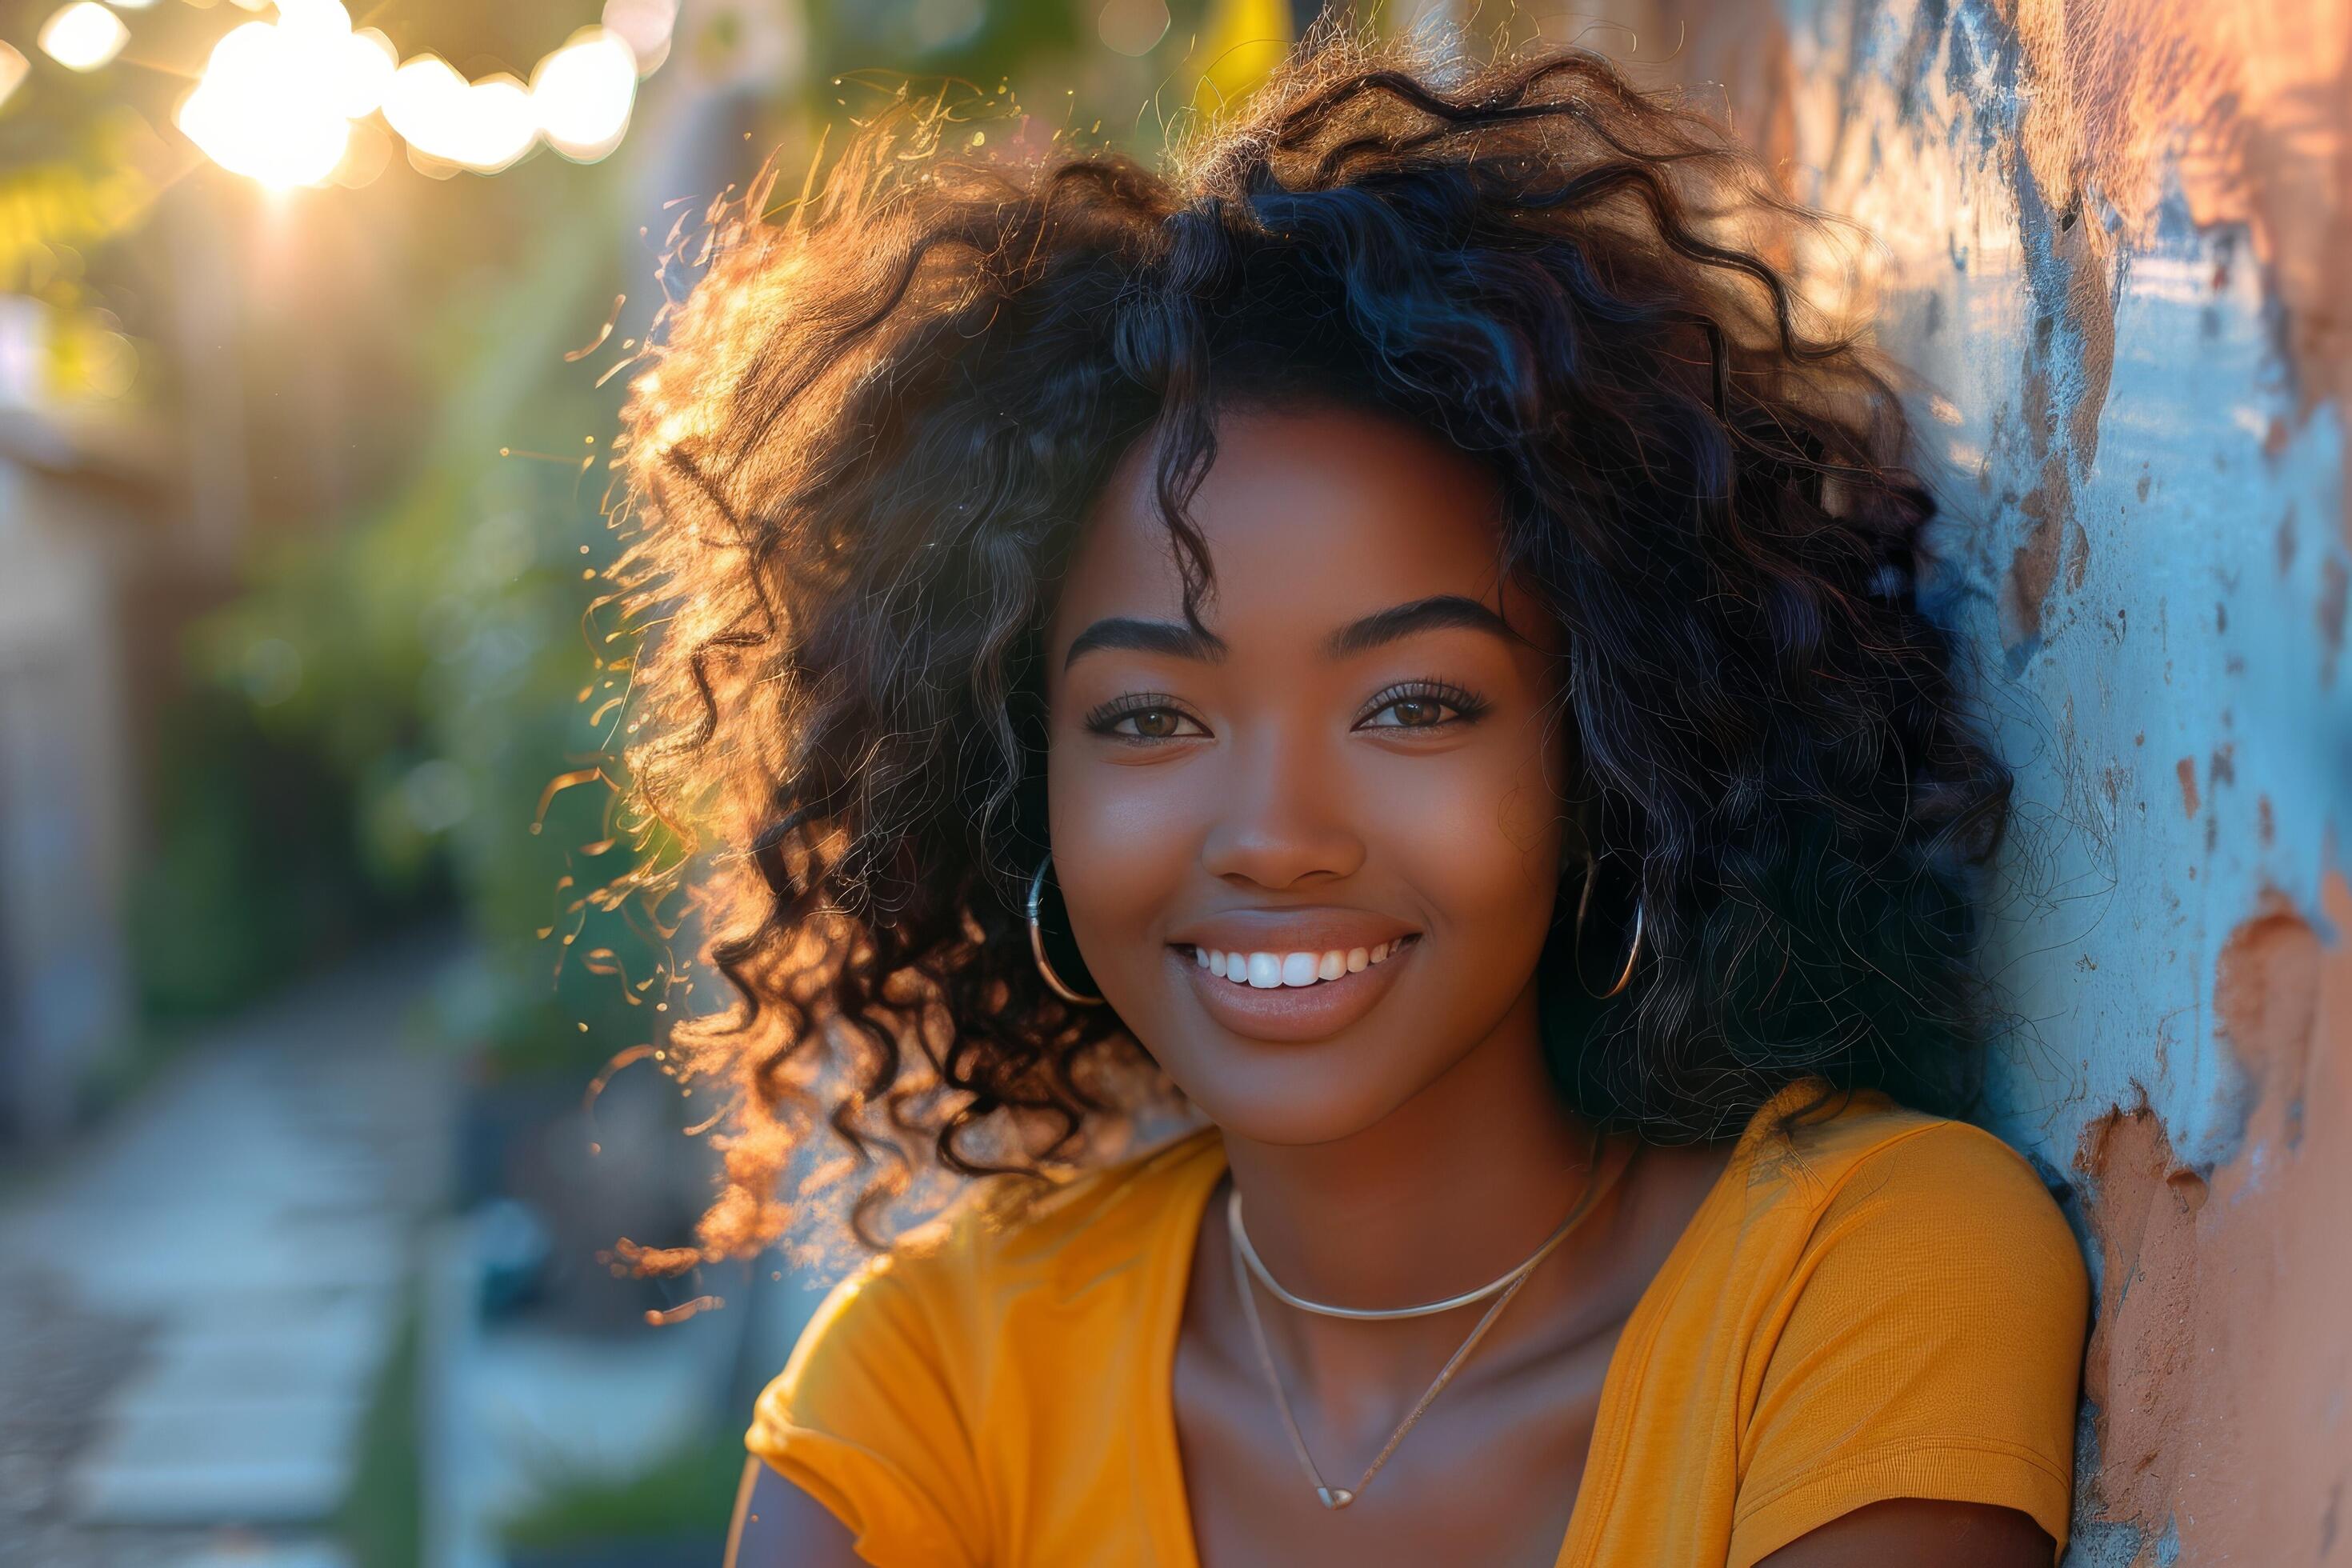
[1046, 409, 1569, 1145]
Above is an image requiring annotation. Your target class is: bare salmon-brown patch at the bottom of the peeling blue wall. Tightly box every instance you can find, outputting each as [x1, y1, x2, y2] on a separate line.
[2074, 872, 2352, 1563]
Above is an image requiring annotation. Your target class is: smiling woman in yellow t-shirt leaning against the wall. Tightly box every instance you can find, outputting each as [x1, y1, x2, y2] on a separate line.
[628, 27, 2086, 1568]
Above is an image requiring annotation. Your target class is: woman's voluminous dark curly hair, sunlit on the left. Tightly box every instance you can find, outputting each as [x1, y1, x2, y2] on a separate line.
[616, 38, 2009, 1258]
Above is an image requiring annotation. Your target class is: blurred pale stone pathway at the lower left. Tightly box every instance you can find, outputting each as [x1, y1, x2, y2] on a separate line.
[0, 942, 456, 1568]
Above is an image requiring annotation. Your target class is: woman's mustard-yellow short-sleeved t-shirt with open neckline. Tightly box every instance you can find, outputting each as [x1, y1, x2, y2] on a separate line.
[746, 1084, 2089, 1568]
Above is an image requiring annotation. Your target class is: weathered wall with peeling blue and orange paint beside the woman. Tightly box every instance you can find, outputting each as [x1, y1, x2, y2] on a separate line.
[1599, 0, 2352, 1568]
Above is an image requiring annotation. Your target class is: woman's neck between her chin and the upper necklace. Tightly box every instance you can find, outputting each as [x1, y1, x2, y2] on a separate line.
[1226, 987, 1592, 1330]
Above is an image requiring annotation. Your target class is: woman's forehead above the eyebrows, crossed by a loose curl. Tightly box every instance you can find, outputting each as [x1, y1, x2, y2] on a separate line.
[1051, 406, 1526, 649]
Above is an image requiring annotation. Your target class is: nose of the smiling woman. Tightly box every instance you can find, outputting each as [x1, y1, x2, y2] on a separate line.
[1199, 724, 1364, 891]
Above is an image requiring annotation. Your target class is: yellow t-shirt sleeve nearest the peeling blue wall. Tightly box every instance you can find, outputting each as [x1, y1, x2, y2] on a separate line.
[1729, 1122, 2089, 1568]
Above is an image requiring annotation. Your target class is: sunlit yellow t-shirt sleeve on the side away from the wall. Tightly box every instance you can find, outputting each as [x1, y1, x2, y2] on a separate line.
[743, 1255, 986, 1568]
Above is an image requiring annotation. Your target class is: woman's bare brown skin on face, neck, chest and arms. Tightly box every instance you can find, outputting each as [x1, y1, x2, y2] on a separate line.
[729, 409, 2051, 1568]
